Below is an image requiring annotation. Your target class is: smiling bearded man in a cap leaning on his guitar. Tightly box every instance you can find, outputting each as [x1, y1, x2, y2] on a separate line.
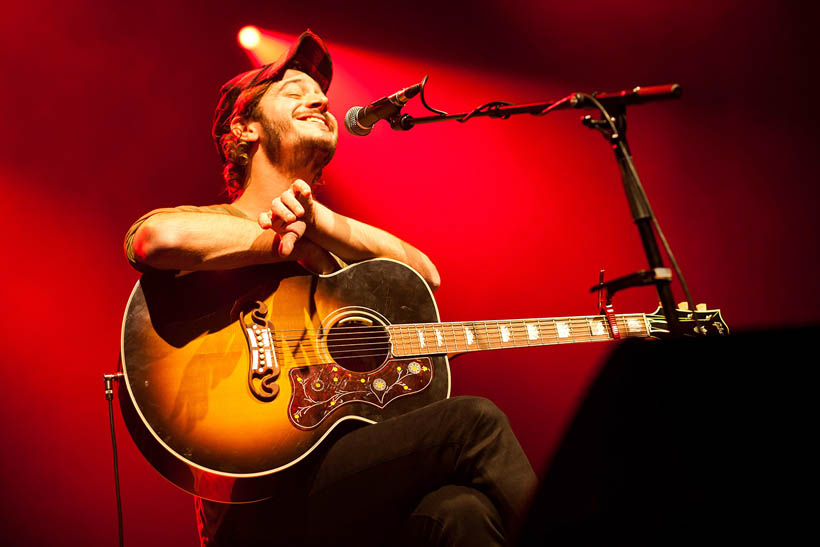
[126, 31, 535, 545]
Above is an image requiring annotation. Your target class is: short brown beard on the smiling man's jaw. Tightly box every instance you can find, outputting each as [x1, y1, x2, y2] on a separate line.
[260, 116, 336, 182]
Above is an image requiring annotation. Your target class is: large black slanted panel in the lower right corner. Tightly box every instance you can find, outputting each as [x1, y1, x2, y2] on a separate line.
[521, 328, 817, 545]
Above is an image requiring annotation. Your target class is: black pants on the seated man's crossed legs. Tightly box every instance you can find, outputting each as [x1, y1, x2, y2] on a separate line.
[199, 397, 536, 547]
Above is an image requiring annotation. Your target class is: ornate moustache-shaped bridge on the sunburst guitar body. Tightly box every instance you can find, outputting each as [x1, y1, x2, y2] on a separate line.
[239, 301, 279, 402]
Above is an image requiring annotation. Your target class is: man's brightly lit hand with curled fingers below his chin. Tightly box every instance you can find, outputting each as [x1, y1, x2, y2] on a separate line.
[257, 179, 314, 258]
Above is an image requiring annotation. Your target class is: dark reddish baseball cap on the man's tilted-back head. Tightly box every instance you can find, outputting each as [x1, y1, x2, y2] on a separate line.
[211, 29, 333, 162]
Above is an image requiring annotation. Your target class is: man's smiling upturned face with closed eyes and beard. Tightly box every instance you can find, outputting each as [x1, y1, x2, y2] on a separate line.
[253, 69, 339, 170]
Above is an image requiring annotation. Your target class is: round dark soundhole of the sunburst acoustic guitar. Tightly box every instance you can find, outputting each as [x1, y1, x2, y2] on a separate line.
[327, 319, 390, 372]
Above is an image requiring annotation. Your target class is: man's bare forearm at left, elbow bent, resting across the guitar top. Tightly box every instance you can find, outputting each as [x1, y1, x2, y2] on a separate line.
[131, 211, 336, 273]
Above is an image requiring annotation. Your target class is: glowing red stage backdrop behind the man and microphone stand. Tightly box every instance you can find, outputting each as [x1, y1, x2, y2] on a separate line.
[0, 0, 820, 547]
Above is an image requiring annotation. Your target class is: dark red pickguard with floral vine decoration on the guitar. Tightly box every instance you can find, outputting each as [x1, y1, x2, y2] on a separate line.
[288, 357, 433, 429]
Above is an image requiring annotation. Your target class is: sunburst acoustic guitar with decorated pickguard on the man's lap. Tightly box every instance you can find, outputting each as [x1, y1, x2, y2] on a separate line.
[119, 259, 728, 503]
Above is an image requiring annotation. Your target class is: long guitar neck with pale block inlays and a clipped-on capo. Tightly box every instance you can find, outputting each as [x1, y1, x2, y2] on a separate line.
[388, 313, 650, 357]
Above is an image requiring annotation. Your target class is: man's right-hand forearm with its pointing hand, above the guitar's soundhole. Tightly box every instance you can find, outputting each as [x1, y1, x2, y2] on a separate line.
[259, 180, 441, 291]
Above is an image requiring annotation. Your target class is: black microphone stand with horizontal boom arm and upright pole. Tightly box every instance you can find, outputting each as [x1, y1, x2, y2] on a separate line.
[388, 84, 694, 336]
